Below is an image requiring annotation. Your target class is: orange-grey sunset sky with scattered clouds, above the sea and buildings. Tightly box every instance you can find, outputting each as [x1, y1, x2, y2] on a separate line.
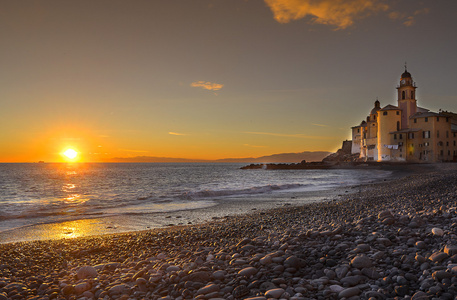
[0, 0, 457, 162]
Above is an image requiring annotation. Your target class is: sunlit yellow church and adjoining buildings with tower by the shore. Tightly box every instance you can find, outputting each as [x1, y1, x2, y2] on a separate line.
[351, 66, 457, 162]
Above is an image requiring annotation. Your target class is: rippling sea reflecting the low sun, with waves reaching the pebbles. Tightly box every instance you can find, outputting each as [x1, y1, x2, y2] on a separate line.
[0, 163, 392, 243]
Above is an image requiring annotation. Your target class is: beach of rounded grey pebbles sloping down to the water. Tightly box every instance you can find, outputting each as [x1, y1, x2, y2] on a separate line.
[0, 164, 457, 300]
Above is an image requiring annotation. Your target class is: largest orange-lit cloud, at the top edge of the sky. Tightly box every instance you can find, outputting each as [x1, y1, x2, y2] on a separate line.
[264, 0, 389, 29]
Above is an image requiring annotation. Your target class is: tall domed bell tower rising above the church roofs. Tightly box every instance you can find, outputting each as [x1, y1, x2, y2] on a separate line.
[397, 63, 417, 129]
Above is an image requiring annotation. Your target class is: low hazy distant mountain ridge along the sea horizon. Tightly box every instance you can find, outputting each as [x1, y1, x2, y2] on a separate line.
[111, 151, 332, 163]
